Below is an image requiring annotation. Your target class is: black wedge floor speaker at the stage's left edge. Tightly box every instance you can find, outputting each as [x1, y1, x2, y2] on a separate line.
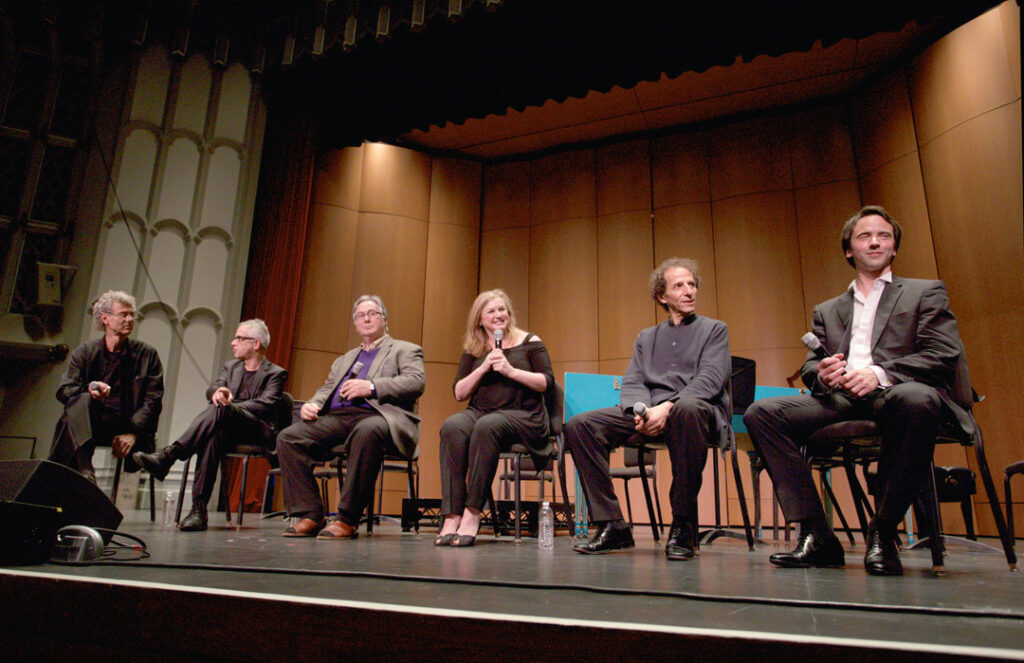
[0, 460, 124, 564]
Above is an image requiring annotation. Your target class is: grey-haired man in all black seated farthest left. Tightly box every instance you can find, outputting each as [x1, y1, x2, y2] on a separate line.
[49, 290, 164, 484]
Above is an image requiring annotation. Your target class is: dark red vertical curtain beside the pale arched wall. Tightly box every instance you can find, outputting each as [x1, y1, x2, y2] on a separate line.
[242, 93, 316, 368]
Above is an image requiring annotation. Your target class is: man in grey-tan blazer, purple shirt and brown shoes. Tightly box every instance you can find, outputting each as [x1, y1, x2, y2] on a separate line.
[278, 295, 426, 541]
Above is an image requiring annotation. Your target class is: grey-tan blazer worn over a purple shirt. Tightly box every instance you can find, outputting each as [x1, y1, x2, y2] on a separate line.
[309, 336, 426, 456]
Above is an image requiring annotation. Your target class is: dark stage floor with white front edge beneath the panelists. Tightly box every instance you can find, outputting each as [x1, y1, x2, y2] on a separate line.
[0, 511, 1024, 660]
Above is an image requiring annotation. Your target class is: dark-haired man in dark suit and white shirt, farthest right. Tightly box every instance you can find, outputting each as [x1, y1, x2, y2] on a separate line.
[743, 206, 974, 575]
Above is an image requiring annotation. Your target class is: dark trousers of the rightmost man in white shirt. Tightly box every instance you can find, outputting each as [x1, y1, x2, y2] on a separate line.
[743, 382, 942, 527]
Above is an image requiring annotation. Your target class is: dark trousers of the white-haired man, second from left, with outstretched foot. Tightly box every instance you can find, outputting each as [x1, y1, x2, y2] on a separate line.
[171, 404, 273, 504]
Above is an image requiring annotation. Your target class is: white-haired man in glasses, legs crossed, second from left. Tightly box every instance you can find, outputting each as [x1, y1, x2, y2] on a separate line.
[132, 318, 288, 532]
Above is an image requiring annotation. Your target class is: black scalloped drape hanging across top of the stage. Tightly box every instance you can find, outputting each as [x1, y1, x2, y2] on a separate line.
[268, 0, 997, 147]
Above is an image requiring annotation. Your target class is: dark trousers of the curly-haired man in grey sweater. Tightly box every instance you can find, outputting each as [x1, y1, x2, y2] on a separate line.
[565, 398, 715, 524]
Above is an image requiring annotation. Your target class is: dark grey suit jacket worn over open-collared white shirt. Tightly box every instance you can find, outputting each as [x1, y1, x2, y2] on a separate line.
[801, 276, 975, 434]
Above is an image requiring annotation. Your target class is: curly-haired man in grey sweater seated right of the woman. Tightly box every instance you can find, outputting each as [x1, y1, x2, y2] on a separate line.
[565, 258, 731, 561]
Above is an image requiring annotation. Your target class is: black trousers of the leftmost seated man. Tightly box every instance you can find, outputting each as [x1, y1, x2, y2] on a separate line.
[47, 393, 154, 471]
